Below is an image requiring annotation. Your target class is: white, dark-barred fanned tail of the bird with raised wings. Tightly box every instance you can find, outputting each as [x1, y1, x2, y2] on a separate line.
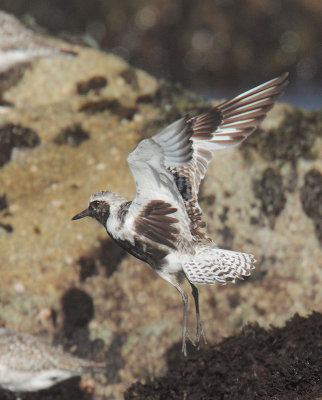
[183, 246, 256, 285]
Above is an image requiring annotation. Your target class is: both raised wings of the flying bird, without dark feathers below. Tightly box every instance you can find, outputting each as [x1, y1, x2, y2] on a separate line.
[127, 74, 288, 241]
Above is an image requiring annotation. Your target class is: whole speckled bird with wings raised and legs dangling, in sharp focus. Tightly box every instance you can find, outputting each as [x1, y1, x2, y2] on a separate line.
[73, 73, 288, 354]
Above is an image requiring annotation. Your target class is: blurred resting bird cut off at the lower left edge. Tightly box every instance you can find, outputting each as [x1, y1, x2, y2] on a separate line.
[0, 328, 105, 393]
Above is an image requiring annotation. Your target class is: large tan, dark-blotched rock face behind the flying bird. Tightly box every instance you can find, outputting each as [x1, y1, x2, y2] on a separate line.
[0, 39, 322, 399]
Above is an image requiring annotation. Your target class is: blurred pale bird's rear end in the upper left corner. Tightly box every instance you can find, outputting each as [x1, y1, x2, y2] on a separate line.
[0, 11, 76, 73]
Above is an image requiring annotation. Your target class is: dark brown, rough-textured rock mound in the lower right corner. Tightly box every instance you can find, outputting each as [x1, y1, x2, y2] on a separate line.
[125, 313, 322, 400]
